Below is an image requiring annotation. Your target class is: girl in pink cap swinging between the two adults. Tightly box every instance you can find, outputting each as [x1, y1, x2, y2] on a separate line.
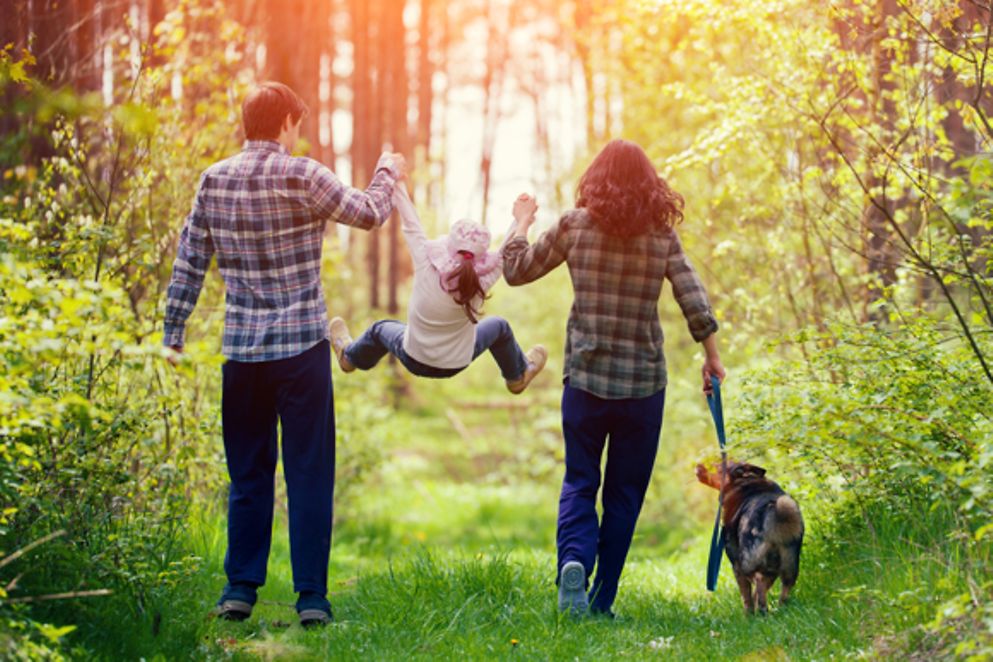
[331, 184, 548, 393]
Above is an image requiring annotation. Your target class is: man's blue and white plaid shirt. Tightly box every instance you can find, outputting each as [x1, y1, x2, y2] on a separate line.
[163, 140, 396, 362]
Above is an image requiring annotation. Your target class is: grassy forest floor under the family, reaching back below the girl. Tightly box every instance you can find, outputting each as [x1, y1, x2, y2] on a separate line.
[60, 288, 961, 660]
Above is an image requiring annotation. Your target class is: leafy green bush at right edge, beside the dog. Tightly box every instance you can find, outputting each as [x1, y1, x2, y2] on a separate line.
[730, 316, 993, 655]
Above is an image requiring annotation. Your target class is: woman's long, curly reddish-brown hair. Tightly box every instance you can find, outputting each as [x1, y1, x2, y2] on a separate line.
[576, 140, 684, 237]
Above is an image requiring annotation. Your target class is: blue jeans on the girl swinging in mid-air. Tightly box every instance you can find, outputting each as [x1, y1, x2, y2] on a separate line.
[345, 317, 528, 381]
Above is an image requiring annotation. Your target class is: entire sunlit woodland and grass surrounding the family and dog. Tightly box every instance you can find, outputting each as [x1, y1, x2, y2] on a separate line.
[0, 0, 993, 659]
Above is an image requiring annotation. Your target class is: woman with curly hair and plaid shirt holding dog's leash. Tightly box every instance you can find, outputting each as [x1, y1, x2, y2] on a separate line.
[502, 140, 724, 616]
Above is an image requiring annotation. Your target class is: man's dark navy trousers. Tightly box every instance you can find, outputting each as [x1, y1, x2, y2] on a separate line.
[221, 340, 335, 596]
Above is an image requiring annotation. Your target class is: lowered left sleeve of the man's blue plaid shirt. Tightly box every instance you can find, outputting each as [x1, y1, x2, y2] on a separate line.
[162, 176, 214, 347]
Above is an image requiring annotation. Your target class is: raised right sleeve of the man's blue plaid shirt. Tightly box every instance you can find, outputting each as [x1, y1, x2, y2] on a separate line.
[310, 156, 397, 230]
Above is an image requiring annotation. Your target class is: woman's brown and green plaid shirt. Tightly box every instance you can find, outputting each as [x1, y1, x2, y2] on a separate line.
[503, 209, 717, 399]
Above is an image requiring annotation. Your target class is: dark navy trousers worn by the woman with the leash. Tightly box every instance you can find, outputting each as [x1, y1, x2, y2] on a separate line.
[557, 382, 665, 612]
